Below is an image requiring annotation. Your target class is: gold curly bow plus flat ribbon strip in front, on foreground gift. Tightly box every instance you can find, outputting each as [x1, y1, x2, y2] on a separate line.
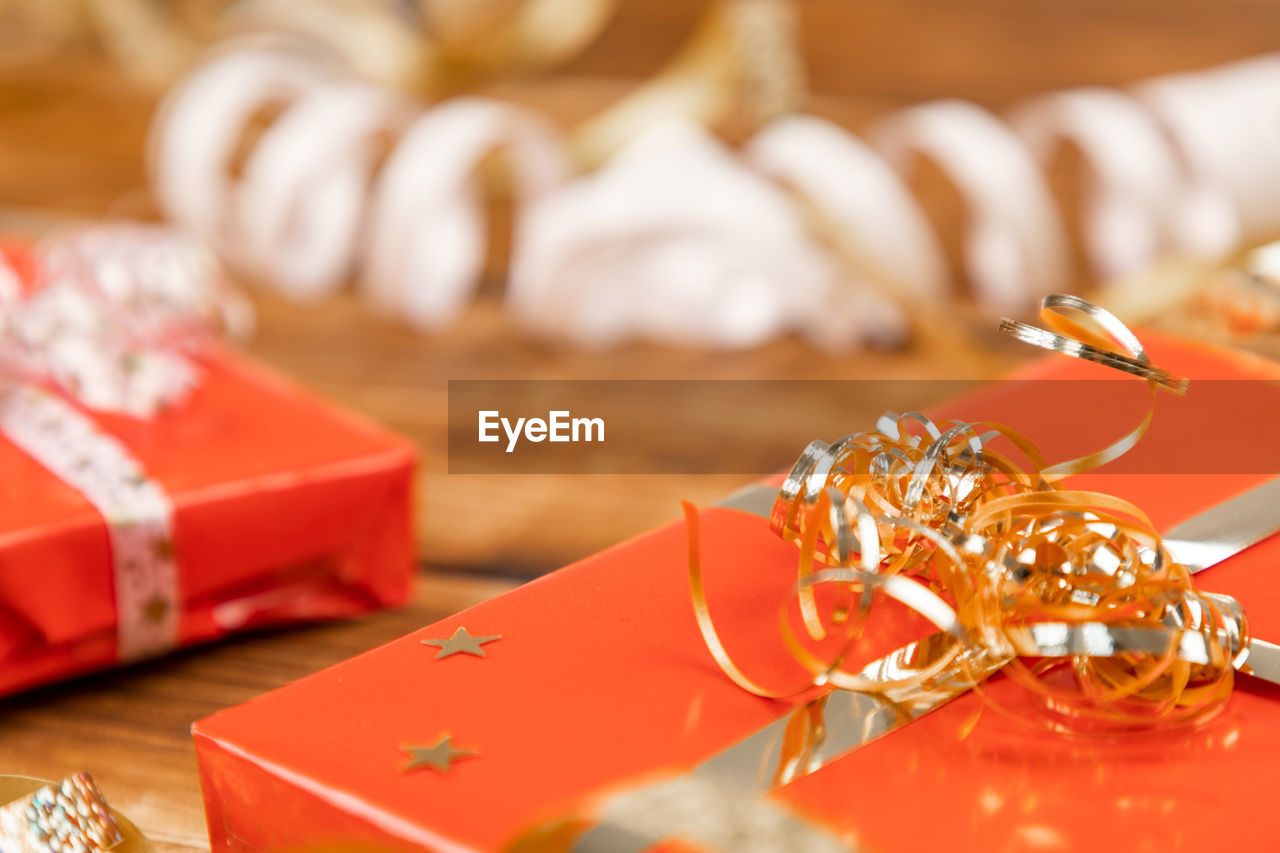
[504, 295, 1259, 853]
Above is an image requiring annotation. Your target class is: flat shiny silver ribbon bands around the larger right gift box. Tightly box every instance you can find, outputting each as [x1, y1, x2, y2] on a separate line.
[571, 479, 1280, 853]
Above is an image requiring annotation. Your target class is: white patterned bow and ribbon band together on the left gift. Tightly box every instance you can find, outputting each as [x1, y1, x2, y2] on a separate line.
[0, 224, 247, 661]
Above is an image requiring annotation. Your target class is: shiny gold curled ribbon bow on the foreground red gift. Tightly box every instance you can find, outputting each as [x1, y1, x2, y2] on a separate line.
[685, 295, 1248, 731]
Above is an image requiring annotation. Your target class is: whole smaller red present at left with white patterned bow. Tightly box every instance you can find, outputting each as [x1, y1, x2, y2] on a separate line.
[0, 227, 415, 694]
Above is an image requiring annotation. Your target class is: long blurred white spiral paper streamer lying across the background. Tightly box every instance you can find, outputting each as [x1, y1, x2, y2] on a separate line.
[151, 31, 1280, 350]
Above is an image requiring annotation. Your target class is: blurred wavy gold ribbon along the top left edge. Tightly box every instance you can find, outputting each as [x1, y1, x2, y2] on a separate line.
[0, 0, 617, 90]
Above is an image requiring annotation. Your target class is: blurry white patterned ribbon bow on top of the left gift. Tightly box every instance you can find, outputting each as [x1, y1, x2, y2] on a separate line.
[0, 224, 252, 418]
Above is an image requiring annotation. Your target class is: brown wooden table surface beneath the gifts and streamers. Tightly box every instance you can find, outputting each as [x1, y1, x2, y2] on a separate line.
[0, 0, 1280, 850]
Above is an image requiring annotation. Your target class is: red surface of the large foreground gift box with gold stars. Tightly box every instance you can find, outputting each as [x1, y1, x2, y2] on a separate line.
[195, 330, 1280, 852]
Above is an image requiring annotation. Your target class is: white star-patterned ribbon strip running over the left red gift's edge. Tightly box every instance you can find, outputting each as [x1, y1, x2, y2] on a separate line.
[0, 386, 178, 661]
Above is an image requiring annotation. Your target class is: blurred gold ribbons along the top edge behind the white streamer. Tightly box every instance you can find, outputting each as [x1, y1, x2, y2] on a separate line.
[70, 0, 805, 147]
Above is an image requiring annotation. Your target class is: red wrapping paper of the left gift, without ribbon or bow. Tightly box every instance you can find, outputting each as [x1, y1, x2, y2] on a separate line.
[0, 351, 415, 694]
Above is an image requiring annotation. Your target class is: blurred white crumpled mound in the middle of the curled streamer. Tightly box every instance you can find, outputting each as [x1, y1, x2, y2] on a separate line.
[507, 123, 906, 351]
